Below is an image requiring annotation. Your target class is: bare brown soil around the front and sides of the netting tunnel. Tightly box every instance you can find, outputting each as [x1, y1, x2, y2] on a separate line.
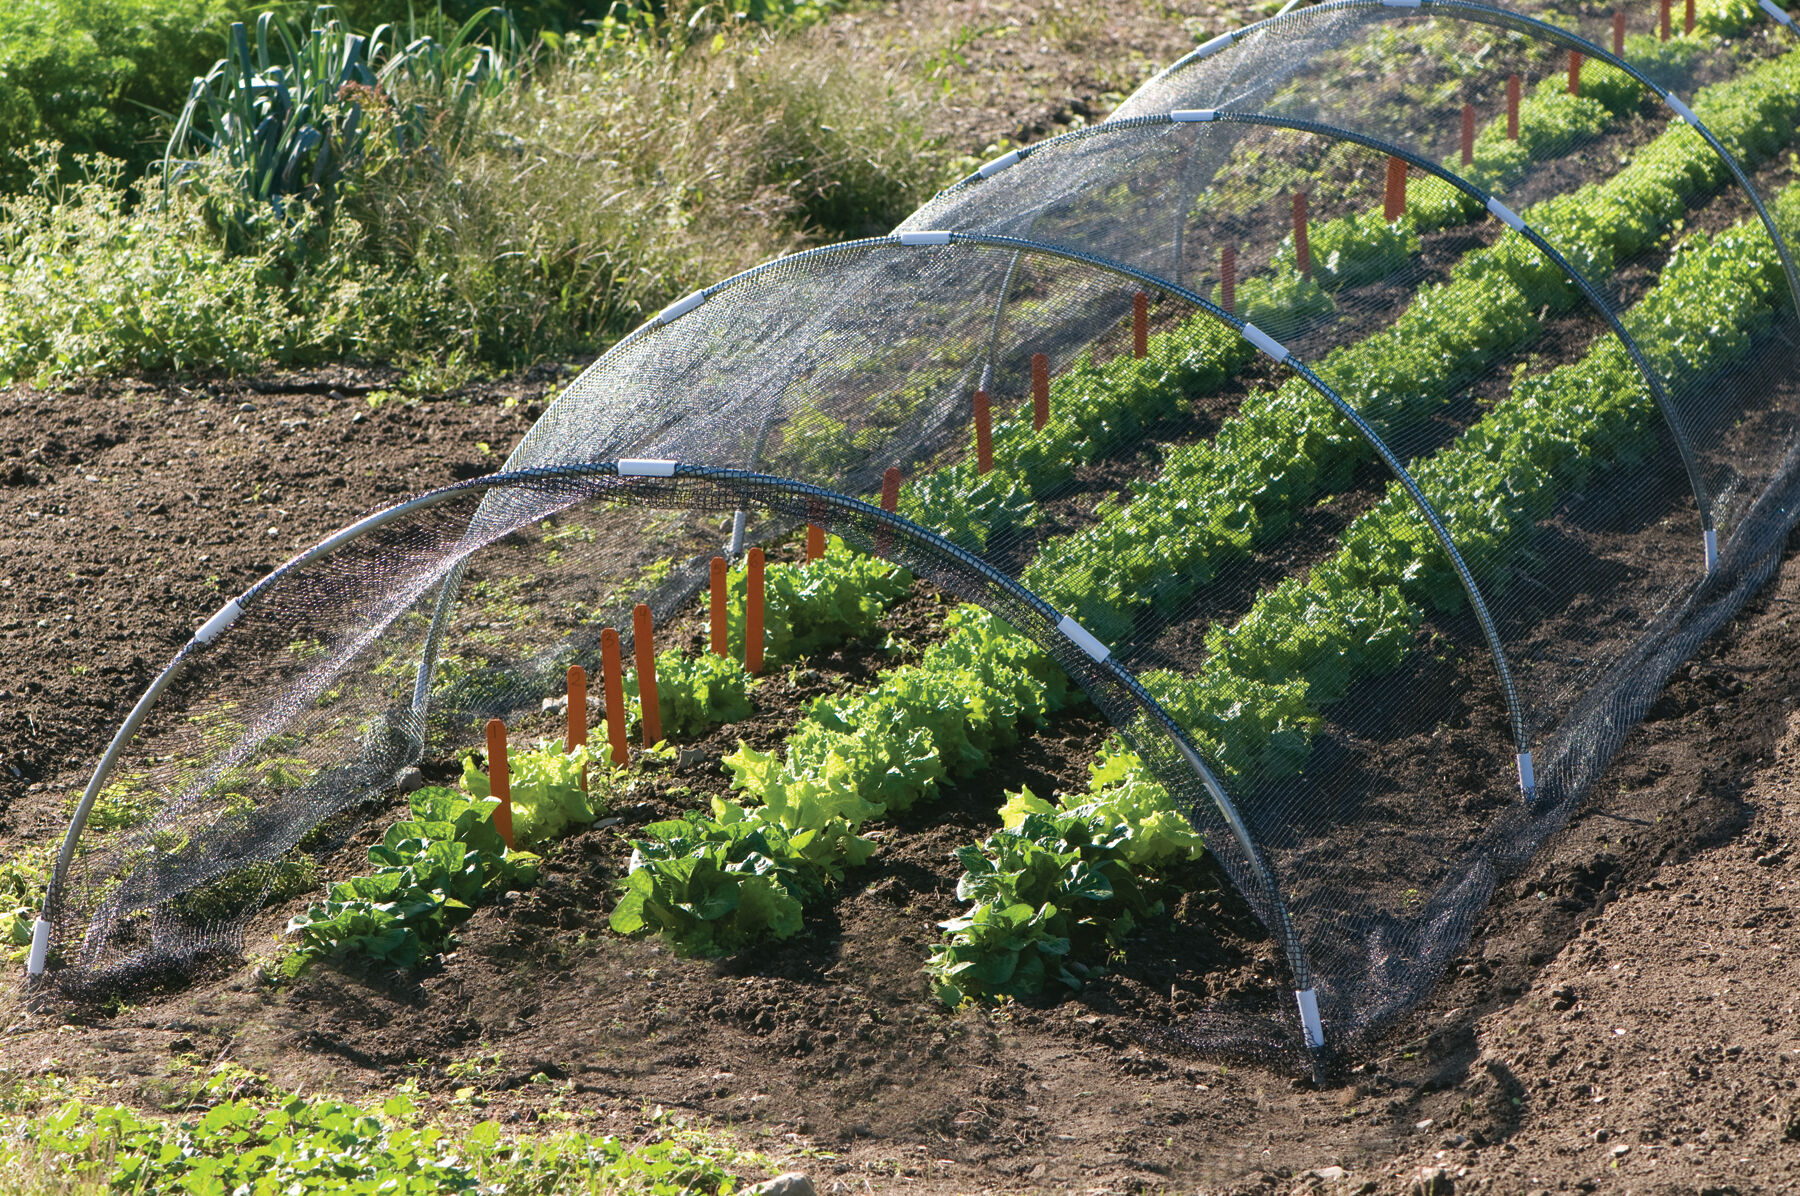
[0, 0, 1800, 1196]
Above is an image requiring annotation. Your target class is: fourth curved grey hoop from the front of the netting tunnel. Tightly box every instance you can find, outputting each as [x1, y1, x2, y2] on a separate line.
[1127, 0, 1800, 320]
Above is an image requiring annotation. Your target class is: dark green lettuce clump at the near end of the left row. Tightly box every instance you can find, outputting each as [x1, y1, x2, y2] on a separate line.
[288, 787, 538, 967]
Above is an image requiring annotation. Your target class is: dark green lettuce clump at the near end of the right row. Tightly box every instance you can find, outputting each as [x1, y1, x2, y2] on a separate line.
[925, 803, 1163, 1005]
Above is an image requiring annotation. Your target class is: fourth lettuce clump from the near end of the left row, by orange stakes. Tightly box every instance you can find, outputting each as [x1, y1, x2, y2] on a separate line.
[720, 535, 913, 659]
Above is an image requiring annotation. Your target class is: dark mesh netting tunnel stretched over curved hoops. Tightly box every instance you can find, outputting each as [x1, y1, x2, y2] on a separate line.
[31, 0, 1800, 1080]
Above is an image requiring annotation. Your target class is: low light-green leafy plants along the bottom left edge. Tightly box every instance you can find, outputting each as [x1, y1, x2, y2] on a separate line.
[0, 1066, 745, 1196]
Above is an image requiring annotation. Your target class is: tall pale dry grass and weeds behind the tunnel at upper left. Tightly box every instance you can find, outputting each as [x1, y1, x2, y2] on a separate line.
[0, 15, 949, 382]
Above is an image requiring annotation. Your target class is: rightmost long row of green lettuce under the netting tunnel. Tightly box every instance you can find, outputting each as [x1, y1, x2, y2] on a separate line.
[927, 161, 1800, 1003]
